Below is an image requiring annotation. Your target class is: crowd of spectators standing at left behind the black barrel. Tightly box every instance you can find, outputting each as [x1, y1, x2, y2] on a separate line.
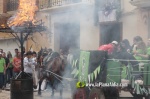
[0, 48, 66, 91]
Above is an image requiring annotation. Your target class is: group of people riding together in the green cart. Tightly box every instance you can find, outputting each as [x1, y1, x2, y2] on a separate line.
[98, 36, 150, 60]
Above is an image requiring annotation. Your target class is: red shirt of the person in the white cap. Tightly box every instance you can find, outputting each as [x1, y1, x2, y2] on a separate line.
[98, 44, 114, 54]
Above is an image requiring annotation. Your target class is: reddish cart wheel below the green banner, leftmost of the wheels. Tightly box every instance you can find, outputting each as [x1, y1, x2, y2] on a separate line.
[74, 88, 87, 99]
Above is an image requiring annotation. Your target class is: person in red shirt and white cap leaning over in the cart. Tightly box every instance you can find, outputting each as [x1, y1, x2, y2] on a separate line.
[98, 41, 118, 55]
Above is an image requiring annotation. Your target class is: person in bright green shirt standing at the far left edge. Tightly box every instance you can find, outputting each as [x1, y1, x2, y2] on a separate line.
[0, 52, 6, 90]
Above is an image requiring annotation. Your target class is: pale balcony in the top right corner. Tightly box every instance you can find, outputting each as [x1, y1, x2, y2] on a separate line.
[130, 0, 150, 8]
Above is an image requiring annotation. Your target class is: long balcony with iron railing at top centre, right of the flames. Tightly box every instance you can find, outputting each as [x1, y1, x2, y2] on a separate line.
[38, 0, 94, 9]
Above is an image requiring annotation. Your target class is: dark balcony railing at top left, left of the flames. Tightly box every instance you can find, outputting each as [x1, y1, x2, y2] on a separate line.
[6, 0, 19, 11]
